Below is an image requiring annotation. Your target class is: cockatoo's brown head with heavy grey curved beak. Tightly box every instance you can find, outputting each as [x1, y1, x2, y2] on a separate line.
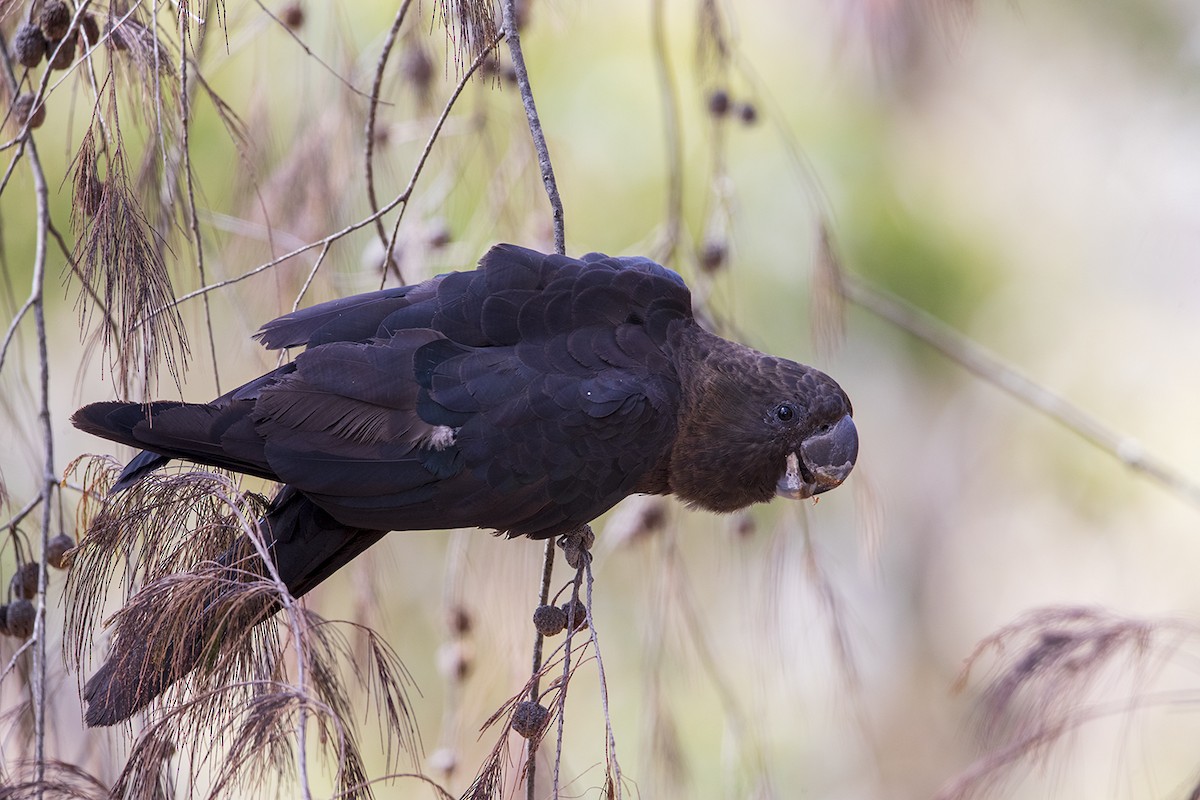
[671, 348, 858, 511]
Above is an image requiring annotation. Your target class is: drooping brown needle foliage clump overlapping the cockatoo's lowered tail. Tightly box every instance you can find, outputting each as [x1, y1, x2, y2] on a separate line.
[65, 459, 421, 798]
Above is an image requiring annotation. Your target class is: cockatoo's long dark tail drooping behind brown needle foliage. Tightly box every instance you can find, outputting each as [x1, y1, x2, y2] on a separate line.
[84, 487, 386, 727]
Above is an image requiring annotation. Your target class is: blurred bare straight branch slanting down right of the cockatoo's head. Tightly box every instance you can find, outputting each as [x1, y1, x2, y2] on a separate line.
[840, 272, 1200, 506]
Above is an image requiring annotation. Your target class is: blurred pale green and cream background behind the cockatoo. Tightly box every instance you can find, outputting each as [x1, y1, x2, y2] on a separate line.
[0, 0, 1200, 799]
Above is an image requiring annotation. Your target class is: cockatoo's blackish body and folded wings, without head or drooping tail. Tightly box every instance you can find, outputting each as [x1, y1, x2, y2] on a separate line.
[113, 245, 691, 537]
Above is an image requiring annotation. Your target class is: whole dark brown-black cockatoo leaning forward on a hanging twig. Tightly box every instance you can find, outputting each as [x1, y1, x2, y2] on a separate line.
[73, 245, 858, 726]
